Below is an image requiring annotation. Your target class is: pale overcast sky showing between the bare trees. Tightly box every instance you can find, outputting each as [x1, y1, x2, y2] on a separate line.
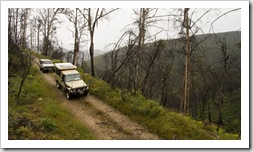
[57, 8, 241, 51]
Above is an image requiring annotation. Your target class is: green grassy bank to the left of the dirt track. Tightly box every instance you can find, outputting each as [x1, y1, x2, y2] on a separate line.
[8, 67, 95, 140]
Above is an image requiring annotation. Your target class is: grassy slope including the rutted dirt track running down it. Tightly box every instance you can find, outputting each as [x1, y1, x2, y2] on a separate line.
[9, 50, 238, 140]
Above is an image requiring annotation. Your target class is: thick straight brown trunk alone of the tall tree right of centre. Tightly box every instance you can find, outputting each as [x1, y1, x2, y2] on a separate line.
[182, 8, 191, 116]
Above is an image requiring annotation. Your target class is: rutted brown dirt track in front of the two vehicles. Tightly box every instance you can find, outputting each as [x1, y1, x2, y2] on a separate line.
[34, 58, 160, 140]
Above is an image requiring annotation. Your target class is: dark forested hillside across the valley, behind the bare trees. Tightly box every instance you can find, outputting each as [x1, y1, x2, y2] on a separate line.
[94, 32, 241, 132]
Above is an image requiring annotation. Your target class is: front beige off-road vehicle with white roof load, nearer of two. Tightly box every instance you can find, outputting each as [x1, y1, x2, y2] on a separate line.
[55, 63, 89, 99]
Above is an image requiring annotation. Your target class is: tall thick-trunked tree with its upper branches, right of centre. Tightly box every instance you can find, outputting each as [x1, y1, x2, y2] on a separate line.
[175, 8, 212, 116]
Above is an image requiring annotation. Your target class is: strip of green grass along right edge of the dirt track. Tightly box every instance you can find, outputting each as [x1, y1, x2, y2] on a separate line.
[79, 72, 238, 140]
